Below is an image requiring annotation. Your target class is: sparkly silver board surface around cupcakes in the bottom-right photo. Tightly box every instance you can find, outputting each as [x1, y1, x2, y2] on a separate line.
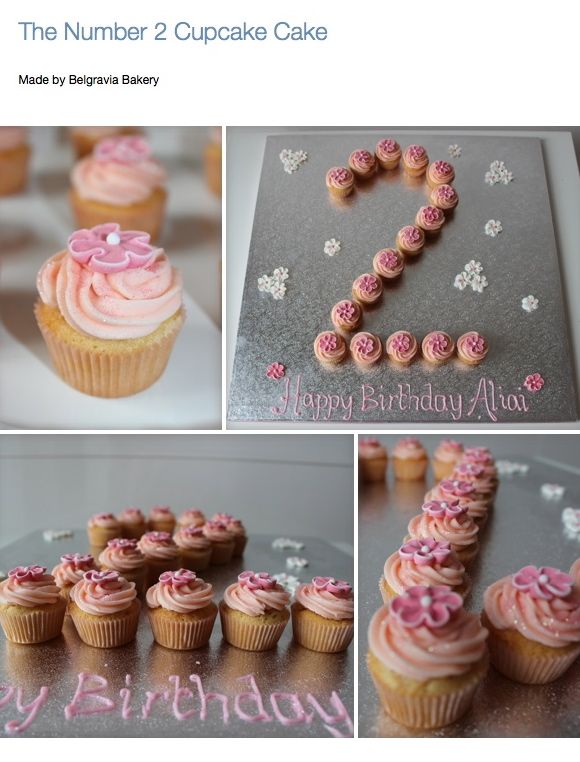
[358, 454, 580, 737]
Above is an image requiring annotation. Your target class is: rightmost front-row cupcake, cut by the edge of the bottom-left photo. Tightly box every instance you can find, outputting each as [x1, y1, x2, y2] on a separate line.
[291, 577, 354, 654]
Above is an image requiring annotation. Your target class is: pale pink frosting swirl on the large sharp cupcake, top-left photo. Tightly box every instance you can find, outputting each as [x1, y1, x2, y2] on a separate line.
[36, 223, 182, 340]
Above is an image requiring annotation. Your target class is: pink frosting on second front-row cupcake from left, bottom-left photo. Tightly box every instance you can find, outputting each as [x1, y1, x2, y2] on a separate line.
[70, 571, 137, 616]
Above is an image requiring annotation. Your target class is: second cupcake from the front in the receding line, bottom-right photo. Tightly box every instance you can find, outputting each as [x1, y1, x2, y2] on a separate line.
[379, 537, 471, 603]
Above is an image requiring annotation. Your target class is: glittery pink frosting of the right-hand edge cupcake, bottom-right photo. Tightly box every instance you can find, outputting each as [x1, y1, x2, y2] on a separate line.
[483, 566, 580, 648]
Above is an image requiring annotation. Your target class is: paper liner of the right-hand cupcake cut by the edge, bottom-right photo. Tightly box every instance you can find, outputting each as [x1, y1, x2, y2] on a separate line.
[488, 631, 580, 685]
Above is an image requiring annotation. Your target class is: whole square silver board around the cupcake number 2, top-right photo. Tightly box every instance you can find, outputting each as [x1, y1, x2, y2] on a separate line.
[228, 132, 577, 424]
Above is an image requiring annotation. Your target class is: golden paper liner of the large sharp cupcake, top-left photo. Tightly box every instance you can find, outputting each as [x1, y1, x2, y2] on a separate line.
[35, 303, 183, 398]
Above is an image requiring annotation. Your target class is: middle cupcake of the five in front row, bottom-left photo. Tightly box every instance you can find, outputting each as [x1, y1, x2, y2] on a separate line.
[147, 569, 217, 651]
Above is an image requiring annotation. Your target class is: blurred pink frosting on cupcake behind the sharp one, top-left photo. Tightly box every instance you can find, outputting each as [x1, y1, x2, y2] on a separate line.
[71, 136, 167, 206]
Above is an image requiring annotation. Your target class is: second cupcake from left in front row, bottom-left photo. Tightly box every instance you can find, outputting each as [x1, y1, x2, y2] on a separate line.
[69, 571, 141, 648]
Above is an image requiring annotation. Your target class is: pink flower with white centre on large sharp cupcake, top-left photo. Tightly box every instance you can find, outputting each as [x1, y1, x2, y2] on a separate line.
[68, 222, 159, 273]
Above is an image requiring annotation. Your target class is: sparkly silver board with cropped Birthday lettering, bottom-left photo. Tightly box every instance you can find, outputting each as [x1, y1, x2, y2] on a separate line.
[0, 531, 354, 738]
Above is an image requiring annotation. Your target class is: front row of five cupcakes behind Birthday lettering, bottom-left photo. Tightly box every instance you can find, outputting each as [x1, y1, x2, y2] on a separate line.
[0, 565, 354, 653]
